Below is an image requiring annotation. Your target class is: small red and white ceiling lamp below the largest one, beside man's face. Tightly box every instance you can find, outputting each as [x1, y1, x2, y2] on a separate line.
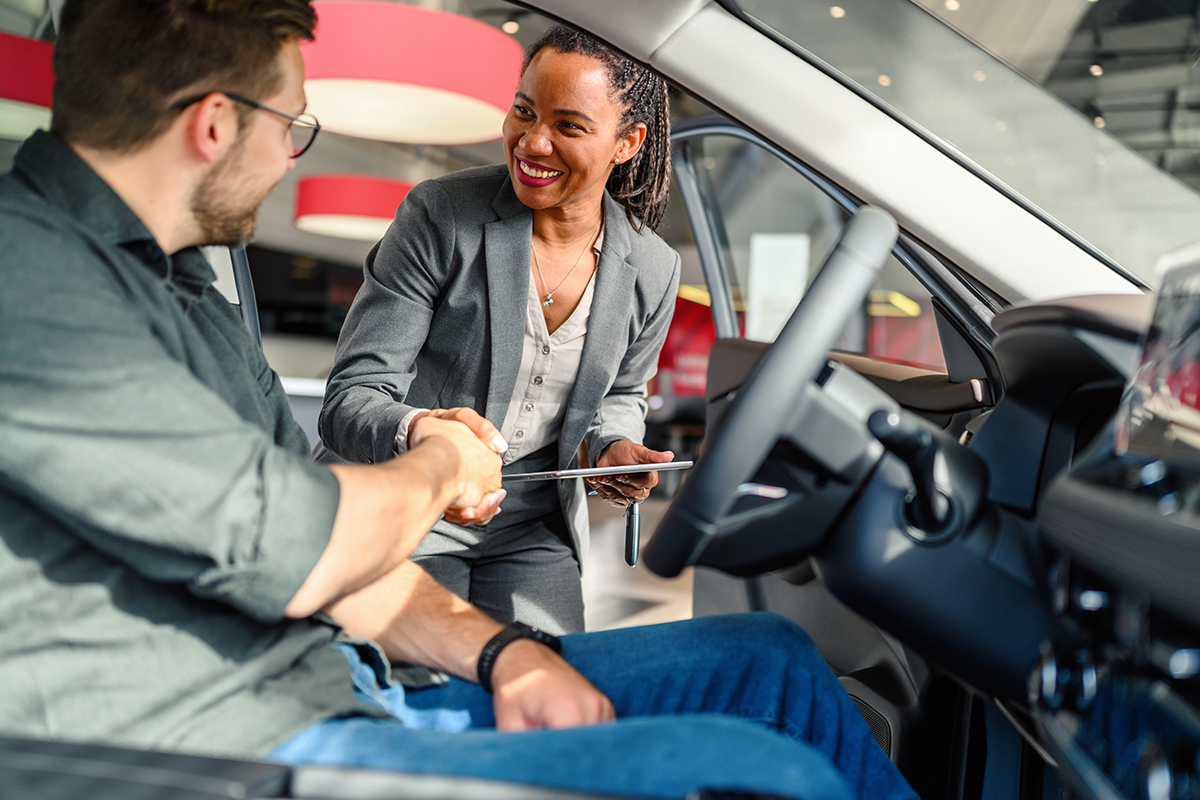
[294, 175, 413, 241]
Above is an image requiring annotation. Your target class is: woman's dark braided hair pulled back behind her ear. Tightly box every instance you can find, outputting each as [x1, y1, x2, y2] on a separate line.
[521, 25, 671, 231]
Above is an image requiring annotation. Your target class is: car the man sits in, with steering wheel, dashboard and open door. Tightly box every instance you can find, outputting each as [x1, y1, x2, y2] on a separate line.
[0, 0, 1200, 800]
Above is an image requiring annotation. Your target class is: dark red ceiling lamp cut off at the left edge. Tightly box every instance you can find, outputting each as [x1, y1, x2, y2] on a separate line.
[0, 31, 54, 140]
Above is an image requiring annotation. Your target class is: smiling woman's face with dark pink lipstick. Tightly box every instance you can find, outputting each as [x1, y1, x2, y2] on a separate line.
[504, 48, 646, 215]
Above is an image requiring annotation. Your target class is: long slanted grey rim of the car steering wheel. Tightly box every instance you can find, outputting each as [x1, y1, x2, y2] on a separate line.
[642, 206, 899, 577]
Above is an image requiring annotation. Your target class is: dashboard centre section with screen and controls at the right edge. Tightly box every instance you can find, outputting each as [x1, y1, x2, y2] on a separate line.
[1030, 284, 1200, 800]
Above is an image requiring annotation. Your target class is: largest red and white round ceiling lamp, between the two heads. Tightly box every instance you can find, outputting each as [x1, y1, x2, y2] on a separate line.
[300, 0, 523, 145]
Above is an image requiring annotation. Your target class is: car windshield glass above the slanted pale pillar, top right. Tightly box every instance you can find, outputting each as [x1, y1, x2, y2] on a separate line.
[737, 0, 1200, 285]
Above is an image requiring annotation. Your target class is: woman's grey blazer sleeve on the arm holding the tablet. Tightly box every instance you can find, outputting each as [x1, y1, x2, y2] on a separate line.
[586, 249, 679, 462]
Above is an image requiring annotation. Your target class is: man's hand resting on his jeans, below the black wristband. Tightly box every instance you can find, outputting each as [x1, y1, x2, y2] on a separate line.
[492, 639, 617, 730]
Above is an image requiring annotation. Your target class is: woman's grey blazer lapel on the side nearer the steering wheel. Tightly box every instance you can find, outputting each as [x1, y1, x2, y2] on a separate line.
[559, 192, 637, 467]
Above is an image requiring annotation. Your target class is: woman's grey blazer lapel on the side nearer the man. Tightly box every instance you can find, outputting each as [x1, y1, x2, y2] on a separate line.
[484, 181, 533, 428]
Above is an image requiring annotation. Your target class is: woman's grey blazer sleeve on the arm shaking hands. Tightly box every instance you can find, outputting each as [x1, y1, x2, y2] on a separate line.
[318, 181, 456, 463]
